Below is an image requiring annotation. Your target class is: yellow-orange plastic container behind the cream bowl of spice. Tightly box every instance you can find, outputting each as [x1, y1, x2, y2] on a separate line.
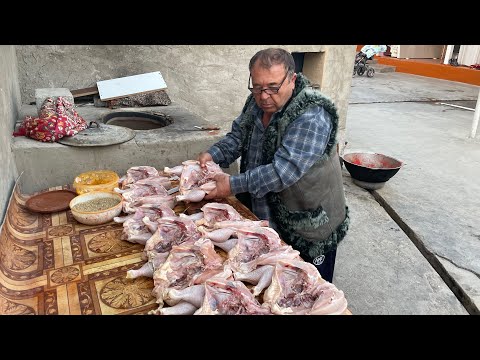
[73, 170, 120, 195]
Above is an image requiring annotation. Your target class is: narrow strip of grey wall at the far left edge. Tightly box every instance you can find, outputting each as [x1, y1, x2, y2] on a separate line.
[0, 45, 21, 223]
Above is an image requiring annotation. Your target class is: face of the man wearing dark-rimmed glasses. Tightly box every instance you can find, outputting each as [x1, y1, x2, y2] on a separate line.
[251, 62, 297, 114]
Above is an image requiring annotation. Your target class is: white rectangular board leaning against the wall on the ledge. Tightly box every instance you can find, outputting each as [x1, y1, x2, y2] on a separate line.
[97, 71, 167, 101]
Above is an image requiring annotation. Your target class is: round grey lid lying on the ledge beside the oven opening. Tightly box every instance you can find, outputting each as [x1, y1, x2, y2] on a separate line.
[57, 121, 135, 146]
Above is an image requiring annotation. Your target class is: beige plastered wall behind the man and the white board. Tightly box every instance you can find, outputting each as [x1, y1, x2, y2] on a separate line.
[16, 45, 355, 148]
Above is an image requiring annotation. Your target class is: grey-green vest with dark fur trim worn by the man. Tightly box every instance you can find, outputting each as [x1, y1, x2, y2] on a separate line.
[236, 73, 349, 261]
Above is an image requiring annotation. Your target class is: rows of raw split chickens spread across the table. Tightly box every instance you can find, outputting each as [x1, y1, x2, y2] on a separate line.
[114, 160, 347, 315]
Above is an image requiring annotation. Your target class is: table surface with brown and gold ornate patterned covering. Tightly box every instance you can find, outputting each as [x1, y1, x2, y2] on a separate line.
[0, 185, 349, 315]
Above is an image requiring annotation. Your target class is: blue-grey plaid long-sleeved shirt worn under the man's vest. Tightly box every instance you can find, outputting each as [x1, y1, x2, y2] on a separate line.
[208, 105, 332, 220]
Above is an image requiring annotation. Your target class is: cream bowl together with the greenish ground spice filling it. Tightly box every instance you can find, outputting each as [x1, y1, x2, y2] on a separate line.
[70, 191, 122, 225]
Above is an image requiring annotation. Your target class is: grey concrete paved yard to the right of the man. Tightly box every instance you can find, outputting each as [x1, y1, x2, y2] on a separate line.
[334, 73, 480, 314]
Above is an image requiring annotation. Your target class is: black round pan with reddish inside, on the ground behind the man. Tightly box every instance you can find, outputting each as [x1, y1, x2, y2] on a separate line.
[343, 152, 403, 183]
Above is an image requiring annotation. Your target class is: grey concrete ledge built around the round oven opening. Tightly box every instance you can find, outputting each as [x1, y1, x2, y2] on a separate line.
[11, 105, 238, 193]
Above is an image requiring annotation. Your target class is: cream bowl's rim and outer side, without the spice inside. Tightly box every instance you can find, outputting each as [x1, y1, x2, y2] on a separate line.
[70, 191, 122, 225]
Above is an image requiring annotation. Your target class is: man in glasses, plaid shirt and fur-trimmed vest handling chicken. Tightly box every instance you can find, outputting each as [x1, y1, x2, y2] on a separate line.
[198, 48, 349, 282]
